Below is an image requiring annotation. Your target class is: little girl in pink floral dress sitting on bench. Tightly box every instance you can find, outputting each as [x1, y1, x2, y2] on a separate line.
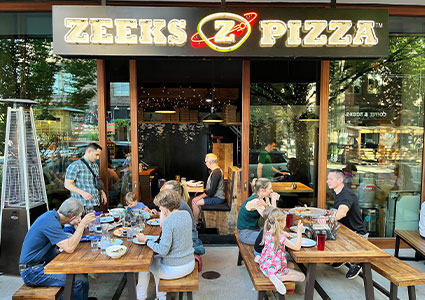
[259, 209, 305, 295]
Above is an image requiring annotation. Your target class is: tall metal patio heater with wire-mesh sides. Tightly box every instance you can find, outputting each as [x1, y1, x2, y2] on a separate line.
[0, 99, 48, 274]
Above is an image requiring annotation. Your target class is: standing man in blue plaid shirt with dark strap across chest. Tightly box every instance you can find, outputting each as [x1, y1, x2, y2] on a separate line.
[65, 143, 107, 210]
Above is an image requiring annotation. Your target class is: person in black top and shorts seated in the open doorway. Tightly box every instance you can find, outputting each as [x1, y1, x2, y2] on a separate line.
[192, 153, 225, 226]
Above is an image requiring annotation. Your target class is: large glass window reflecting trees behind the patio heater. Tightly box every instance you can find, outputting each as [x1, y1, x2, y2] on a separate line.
[0, 37, 99, 208]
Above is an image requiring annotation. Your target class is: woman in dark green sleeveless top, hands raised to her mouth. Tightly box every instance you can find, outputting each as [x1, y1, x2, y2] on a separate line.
[237, 178, 279, 245]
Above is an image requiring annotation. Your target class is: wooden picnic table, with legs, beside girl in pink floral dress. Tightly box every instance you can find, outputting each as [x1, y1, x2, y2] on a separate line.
[287, 224, 390, 300]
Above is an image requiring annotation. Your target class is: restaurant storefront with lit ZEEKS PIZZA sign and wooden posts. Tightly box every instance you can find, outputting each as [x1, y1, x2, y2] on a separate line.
[0, 1, 425, 245]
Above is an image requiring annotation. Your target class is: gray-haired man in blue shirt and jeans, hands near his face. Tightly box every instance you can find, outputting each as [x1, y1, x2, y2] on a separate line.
[19, 198, 95, 300]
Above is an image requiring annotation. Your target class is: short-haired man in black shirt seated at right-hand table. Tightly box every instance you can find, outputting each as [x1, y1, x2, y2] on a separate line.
[327, 169, 368, 279]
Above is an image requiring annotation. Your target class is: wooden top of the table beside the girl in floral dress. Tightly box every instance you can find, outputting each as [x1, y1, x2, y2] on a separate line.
[287, 224, 390, 263]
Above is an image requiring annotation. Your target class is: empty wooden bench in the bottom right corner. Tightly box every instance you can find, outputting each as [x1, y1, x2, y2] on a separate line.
[372, 256, 425, 300]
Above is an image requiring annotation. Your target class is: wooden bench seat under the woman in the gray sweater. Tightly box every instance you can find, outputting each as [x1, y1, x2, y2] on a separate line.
[158, 262, 198, 300]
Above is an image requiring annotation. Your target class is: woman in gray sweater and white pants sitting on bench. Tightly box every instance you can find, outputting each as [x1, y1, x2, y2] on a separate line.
[137, 190, 195, 300]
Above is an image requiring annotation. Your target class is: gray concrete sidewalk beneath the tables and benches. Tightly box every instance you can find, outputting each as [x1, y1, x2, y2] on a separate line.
[0, 246, 425, 300]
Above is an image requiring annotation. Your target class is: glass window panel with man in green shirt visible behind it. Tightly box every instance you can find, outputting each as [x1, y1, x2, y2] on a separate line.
[249, 62, 319, 207]
